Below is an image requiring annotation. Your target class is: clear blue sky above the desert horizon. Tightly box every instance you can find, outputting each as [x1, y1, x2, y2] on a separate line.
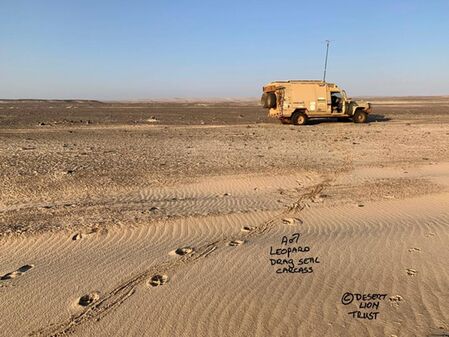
[0, 0, 449, 99]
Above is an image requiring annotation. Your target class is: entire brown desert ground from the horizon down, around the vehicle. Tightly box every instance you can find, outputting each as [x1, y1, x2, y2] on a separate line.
[0, 97, 449, 337]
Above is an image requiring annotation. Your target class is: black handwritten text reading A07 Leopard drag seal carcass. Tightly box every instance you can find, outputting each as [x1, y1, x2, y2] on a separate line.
[270, 233, 320, 274]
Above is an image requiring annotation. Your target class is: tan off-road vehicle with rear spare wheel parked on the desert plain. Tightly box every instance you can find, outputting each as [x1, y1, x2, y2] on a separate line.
[261, 80, 371, 125]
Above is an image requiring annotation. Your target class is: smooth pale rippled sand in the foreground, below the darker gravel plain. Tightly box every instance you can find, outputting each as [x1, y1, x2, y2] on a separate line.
[0, 164, 449, 336]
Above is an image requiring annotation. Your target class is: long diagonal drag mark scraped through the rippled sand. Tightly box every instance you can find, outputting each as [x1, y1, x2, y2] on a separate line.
[29, 180, 329, 337]
